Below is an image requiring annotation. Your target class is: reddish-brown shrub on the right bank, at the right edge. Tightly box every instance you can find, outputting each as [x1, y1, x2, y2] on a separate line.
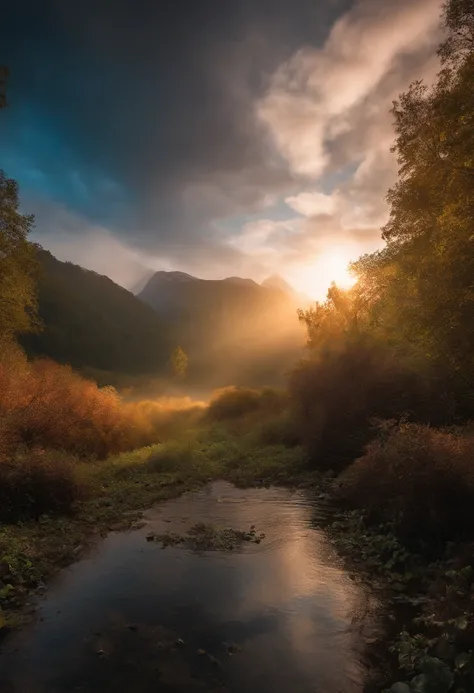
[338, 423, 474, 539]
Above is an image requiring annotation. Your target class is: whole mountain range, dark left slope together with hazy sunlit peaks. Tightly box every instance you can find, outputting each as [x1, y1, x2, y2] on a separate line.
[22, 255, 304, 389]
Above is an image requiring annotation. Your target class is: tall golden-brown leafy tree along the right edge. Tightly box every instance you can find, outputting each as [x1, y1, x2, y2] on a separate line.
[354, 0, 474, 389]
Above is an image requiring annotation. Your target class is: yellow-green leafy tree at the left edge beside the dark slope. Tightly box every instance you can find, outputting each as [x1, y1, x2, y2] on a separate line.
[0, 170, 36, 338]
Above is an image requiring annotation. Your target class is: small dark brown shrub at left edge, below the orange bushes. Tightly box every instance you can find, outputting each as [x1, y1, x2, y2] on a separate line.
[0, 450, 82, 522]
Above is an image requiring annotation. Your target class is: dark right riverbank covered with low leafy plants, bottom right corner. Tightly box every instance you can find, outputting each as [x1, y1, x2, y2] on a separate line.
[325, 506, 474, 693]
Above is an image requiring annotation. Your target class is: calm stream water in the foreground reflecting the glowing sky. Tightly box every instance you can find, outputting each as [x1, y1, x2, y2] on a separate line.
[0, 482, 378, 693]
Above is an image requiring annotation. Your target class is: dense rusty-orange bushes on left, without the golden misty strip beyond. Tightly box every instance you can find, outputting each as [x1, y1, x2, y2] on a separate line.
[0, 345, 133, 457]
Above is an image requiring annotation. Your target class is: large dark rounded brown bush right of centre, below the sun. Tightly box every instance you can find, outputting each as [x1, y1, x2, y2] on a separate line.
[289, 340, 428, 469]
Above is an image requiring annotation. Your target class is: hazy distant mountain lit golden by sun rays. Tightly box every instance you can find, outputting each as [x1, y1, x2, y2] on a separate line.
[139, 272, 304, 385]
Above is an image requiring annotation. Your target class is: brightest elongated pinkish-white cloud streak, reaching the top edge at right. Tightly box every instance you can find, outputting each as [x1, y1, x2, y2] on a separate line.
[257, 0, 440, 177]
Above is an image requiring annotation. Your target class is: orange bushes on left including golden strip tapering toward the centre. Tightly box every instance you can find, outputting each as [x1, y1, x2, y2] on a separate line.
[0, 343, 203, 459]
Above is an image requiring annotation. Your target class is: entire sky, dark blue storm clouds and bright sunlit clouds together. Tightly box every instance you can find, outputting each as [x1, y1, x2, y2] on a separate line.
[0, 0, 441, 298]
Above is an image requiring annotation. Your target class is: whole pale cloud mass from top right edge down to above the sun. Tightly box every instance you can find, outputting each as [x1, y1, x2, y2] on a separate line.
[241, 0, 440, 288]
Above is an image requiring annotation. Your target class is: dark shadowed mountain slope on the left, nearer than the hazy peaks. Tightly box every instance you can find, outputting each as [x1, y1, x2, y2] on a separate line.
[22, 250, 171, 374]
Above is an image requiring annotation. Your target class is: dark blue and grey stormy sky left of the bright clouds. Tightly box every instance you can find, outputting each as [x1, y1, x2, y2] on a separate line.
[0, 0, 440, 294]
